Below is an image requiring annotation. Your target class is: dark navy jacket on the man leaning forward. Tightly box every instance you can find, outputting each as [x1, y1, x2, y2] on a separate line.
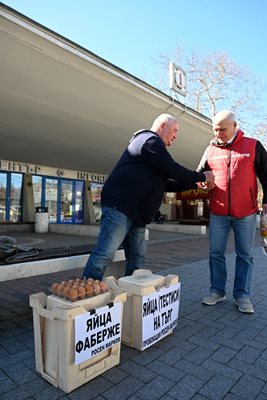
[101, 130, 205, 226]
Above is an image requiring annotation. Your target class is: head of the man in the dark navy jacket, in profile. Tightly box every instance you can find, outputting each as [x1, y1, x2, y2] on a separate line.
[151, 114, 179, 146]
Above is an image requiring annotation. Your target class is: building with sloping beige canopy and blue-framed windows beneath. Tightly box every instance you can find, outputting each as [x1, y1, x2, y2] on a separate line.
[0, 3, 212, 230]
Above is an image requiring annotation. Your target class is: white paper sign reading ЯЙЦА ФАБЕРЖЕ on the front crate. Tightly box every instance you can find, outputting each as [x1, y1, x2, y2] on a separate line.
[75, 302, 122, 365]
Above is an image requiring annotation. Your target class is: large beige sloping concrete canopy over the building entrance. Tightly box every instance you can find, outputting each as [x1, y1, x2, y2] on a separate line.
[0, 5, 212, 174]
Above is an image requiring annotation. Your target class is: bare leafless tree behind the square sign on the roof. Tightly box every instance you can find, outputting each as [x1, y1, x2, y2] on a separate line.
[155, 47, 266, 135]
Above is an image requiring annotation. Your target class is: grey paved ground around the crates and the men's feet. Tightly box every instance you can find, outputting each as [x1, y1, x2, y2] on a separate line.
[0, 232, 267, 400]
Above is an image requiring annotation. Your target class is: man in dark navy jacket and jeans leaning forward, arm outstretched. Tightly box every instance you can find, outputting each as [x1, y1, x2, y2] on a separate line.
[83, 114, 214, 280]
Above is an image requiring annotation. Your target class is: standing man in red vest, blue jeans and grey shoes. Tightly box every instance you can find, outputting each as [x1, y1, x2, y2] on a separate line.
[197, 110, 267, 314]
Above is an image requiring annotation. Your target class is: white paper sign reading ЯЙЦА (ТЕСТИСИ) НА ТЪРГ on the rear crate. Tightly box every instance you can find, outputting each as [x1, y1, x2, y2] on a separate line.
[142, 282, 181, 350]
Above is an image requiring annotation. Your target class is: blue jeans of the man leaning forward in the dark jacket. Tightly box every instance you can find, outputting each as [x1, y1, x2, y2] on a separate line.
[83, 207, 146, 280]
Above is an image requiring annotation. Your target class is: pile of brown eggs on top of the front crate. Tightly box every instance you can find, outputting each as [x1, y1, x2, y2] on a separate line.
[51, 278, 108, 301]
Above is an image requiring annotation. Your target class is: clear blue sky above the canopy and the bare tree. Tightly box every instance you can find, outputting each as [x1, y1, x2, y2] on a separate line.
[3, 0, 267, 123]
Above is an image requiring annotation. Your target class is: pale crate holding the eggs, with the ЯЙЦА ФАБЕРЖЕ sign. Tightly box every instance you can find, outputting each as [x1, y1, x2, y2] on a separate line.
[30, 279, 127, 393]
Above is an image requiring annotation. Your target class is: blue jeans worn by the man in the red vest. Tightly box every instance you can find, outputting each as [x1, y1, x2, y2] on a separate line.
[209, 214, 256, 300]
